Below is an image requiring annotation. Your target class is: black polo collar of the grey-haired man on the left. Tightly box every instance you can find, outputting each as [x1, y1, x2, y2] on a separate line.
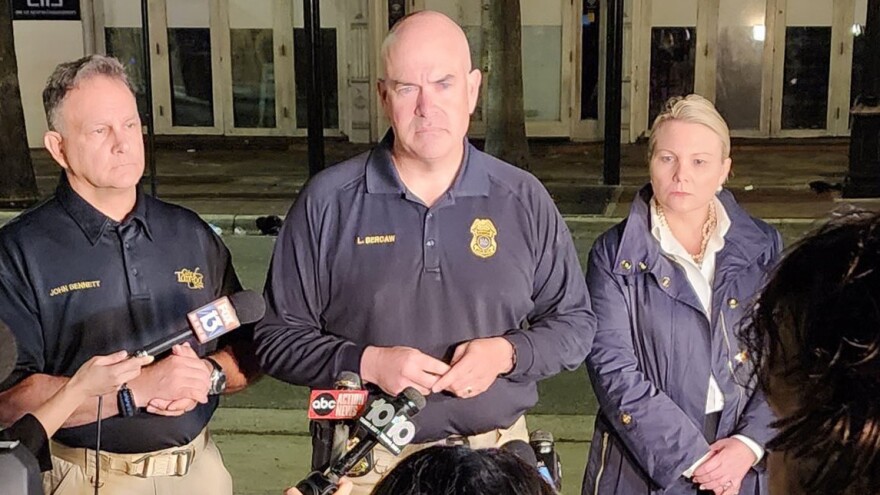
[55, 172, 153, 246]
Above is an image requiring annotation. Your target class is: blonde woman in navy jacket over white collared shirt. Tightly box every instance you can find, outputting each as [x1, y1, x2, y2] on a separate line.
[583, 95, 781, 495]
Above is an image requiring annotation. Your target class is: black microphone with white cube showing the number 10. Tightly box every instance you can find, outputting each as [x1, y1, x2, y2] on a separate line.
[296, 387, 426, 495]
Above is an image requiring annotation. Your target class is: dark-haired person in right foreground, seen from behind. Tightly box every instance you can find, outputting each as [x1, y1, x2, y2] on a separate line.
[742, 212, 880, 495]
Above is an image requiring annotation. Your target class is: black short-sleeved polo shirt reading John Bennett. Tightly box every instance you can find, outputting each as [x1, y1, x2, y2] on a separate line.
[0, 178, 243, 453]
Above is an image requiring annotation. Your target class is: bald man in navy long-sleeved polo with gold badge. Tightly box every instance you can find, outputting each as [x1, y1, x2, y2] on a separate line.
[255, 12, 595, 493]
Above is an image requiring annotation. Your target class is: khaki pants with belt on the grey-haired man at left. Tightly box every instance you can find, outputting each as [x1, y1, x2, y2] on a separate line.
[43, 429, 232, 495]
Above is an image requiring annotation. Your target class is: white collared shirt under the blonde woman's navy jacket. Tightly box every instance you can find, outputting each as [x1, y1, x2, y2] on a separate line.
[650, 197, 764, 478]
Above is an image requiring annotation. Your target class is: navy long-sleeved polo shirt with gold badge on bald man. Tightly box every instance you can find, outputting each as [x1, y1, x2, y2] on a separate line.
[255, 133, 595, 442]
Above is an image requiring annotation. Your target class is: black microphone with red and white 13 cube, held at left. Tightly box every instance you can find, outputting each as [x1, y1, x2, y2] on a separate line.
[133, 290, 266, 357]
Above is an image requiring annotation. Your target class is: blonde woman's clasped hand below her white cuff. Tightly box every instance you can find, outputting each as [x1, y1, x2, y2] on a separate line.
[693, 438, 757, 495]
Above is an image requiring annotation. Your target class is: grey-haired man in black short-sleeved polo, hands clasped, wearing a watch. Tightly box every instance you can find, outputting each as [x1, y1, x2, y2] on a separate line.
[0, 55, 250, 495]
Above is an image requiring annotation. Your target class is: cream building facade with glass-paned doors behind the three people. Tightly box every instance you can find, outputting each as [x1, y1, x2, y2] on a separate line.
[13, 0, 867, 147]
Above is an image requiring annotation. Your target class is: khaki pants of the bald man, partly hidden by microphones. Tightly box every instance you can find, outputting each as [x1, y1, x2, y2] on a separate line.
[351, 416, 529, 495]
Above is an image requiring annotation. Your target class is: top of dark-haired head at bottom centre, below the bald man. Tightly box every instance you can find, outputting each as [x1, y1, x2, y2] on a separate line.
[372, 446, 554, 495]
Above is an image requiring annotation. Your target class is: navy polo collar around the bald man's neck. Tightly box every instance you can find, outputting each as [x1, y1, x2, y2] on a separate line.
[366, 129, 489, 197]
